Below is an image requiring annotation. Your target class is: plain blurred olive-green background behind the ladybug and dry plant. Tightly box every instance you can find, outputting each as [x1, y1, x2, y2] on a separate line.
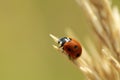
[0, 0, 120, 80]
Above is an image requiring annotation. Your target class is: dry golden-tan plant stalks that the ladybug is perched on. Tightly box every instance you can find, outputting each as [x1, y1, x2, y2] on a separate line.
[50, 0, 120, 80]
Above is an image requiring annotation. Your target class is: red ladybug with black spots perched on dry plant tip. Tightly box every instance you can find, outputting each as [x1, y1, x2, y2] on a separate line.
[58, 37, 82, 59]
